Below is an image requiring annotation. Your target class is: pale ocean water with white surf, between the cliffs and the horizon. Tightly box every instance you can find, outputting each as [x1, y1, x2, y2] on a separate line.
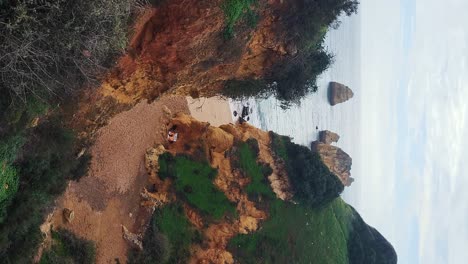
[231, 13, 361, 196]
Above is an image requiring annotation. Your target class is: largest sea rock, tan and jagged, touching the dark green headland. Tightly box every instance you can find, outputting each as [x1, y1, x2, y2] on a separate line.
[311, 141, 354, 186]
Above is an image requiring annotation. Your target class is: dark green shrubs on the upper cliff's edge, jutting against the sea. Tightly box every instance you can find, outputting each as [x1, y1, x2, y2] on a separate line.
[222, 0, 359, 108]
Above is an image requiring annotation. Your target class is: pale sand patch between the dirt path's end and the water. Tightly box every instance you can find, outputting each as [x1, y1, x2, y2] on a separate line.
[186, 97, 233, 126]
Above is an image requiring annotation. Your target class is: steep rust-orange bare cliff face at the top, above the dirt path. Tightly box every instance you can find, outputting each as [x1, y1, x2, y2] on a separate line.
[103, 0, 297, 103]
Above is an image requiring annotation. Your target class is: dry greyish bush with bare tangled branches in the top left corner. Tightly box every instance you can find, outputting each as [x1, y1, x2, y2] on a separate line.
[0, 0, 134, 98]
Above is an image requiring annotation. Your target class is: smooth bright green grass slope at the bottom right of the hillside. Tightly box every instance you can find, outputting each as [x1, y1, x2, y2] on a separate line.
[229, 198, 352, 264]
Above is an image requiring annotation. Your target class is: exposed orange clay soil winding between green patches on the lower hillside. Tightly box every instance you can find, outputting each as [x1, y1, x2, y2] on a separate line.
[143, 114, 291, 263]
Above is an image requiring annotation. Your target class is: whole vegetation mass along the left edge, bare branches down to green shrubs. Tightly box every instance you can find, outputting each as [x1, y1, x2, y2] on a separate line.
[0, 0, 134, 263]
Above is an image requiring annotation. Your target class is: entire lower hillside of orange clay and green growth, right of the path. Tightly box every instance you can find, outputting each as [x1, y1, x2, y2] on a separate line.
[130, 114, 397, 263]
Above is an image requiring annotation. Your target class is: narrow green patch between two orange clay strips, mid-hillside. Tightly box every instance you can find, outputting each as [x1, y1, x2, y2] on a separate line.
[238, 138, 275, 198]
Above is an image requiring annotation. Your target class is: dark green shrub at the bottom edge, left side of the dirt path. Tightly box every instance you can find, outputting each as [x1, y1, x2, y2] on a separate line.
[39, 229, 96, 264]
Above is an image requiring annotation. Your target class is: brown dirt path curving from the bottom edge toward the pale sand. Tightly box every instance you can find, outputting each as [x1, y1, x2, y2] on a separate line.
[52, 97, 189, 263]
